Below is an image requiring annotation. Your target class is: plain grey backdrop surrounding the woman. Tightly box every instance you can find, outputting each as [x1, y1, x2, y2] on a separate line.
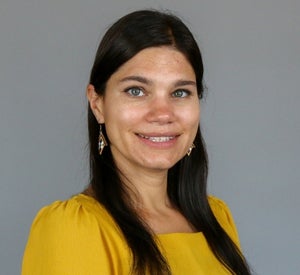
[0, 0, 300, 275]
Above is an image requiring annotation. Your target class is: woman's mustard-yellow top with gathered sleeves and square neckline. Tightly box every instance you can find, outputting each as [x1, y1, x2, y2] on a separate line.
[22, 194, 239, 275]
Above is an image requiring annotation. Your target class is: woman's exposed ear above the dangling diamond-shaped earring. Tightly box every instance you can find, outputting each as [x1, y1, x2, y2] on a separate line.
[86, 84, 104, 124]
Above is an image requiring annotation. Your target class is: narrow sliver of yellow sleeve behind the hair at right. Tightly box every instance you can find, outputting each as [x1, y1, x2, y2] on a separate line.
[209, 196, 240, 248]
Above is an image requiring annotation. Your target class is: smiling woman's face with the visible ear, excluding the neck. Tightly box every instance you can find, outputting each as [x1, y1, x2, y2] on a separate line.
[88, 47, 200, 172]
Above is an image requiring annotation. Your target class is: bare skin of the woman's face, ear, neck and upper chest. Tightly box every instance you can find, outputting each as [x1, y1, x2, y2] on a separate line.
[87, 46, 200, 233]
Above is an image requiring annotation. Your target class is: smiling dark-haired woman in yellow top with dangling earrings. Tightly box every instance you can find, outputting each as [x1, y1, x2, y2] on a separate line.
[22, 10, 250, 275]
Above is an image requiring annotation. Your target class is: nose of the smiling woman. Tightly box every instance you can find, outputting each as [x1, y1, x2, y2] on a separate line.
[147, 96, 175, 124]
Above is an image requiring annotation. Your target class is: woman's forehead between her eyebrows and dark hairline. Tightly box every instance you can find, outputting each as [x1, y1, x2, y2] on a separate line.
[112, 46, 195, 79]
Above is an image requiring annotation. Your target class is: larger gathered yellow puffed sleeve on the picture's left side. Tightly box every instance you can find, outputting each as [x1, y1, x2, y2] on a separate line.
[22, 201, 110, 275]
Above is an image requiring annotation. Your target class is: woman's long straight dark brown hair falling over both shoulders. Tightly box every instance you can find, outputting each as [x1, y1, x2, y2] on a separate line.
[88, 10, 250, 275]
